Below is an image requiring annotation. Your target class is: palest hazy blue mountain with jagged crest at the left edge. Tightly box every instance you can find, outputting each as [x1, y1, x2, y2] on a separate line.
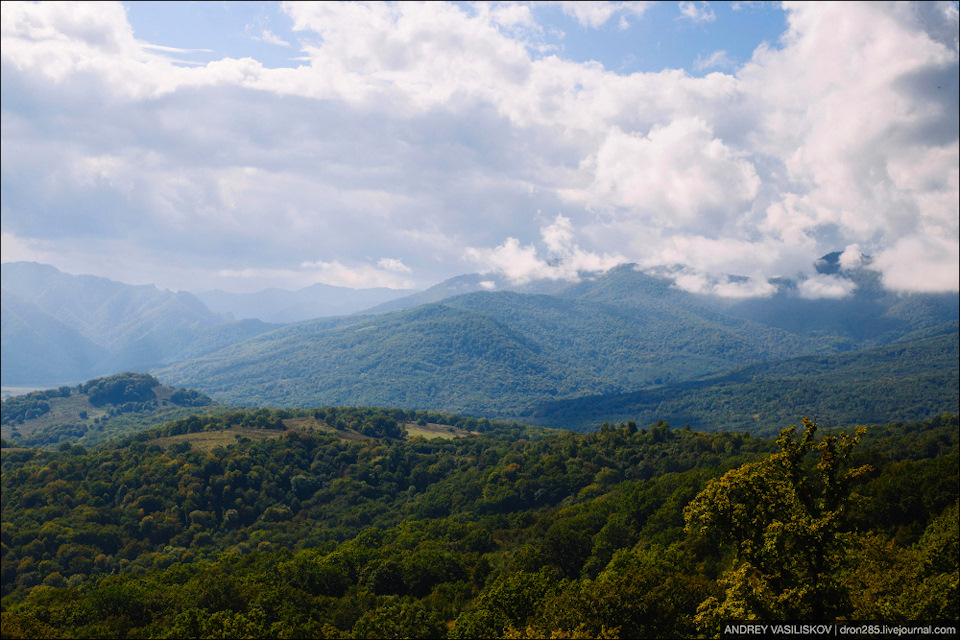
[2, 262, 276, 386]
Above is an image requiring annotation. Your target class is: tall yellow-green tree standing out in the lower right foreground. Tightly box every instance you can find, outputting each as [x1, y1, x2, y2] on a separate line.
[684, 418, 870, 628]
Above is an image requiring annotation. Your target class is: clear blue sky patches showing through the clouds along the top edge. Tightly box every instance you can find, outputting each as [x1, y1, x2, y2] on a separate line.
[125, 2, 786, 75]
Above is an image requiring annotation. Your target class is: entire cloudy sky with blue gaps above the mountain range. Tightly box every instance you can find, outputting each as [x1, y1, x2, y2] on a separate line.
[0, 2, 960, 298]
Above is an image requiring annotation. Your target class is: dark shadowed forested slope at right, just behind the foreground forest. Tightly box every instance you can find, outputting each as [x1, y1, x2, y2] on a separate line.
[527, 323, 960, 435]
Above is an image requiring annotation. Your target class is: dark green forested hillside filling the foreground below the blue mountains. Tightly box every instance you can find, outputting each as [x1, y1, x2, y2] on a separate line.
[2, 408, 960, 638]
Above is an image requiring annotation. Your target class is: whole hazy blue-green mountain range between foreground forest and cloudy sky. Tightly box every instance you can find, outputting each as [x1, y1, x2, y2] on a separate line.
[3, 254, 958, 436]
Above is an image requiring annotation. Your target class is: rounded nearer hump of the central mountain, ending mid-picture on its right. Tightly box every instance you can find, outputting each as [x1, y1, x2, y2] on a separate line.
[157, 305, 592, 414]
